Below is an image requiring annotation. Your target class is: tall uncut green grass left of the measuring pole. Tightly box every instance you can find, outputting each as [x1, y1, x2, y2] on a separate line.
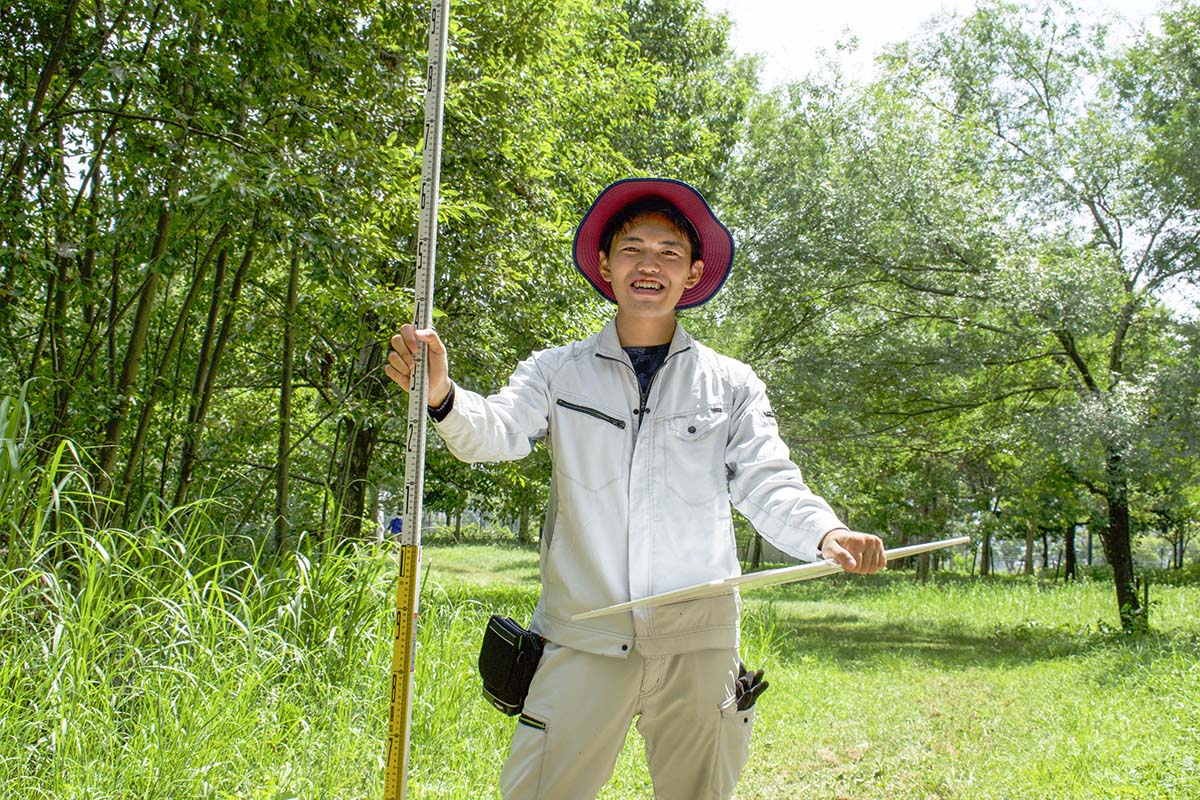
[0, 386, 394, 800]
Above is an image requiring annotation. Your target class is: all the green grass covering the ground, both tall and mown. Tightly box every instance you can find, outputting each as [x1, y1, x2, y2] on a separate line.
[0, 386, 1200, 800]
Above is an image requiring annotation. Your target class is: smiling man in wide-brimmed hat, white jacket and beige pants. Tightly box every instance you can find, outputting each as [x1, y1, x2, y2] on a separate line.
[386, 179, 884, 800]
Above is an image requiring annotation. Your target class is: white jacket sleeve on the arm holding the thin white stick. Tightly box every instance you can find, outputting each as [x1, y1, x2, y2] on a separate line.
[726, 367, 844, 561]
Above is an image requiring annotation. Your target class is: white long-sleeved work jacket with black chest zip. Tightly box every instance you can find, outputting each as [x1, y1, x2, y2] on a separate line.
[434, 323, 841, 657]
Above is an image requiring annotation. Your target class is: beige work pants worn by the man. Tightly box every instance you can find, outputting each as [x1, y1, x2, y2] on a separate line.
[500, 642, 755, 800]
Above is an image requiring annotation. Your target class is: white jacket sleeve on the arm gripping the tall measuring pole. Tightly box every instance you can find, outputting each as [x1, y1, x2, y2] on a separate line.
[433, 354, 550, 463]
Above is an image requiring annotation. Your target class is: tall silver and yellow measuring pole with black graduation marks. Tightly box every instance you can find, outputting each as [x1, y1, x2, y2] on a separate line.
[384, 0, 450, 800]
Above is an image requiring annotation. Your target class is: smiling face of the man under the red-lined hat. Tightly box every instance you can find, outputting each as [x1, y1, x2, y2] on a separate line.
[600, 215, 704, 315]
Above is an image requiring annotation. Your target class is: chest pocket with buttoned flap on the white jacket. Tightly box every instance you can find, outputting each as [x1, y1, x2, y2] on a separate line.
[660, 405, 730, 503]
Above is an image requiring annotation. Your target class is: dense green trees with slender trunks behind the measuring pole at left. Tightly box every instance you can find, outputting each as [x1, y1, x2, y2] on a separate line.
[0, 0, 754, 544]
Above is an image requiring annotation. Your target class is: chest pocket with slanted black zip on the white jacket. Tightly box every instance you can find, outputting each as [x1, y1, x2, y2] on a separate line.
[550, 396, 629, 491]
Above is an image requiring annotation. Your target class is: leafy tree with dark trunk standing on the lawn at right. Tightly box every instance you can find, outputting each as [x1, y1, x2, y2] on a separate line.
[720, 4, 1198, 628]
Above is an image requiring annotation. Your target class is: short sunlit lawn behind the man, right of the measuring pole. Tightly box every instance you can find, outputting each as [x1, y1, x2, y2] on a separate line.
[413, 546, 1200, 800]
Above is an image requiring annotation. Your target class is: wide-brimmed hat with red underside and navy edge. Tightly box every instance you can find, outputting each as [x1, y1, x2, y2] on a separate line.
[572, 178, 733, 308]
